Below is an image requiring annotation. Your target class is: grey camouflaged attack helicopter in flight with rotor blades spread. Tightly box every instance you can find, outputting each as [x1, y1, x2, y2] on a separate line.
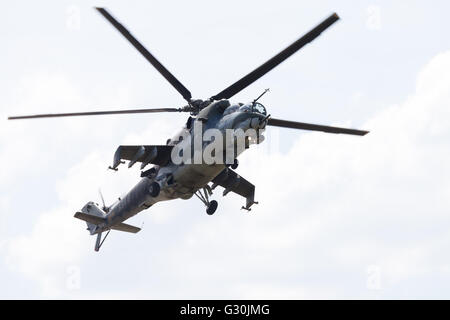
[8, 8, 368, 251]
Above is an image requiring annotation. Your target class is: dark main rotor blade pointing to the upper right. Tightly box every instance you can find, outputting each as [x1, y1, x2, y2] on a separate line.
[211, 13, 339, 100]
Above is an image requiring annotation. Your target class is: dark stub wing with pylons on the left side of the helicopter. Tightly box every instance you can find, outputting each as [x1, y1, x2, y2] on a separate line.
[110, 146, 173, 170]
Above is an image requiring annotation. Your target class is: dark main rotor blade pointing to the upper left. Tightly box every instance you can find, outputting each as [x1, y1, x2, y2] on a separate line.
[95, 7, 192, 102]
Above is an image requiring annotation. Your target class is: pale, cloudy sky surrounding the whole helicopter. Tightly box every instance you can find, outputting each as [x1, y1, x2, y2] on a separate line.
[0, 0, 450, 299]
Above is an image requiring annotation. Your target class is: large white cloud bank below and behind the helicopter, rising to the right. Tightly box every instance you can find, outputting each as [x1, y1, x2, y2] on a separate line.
[2, 52, 450, 298]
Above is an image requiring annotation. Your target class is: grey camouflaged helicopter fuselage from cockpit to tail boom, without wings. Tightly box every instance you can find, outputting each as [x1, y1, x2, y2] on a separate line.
[89, 100, 267, 234]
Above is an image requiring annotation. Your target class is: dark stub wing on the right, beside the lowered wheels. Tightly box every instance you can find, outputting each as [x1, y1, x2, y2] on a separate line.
[212, 168, 257, 210]
